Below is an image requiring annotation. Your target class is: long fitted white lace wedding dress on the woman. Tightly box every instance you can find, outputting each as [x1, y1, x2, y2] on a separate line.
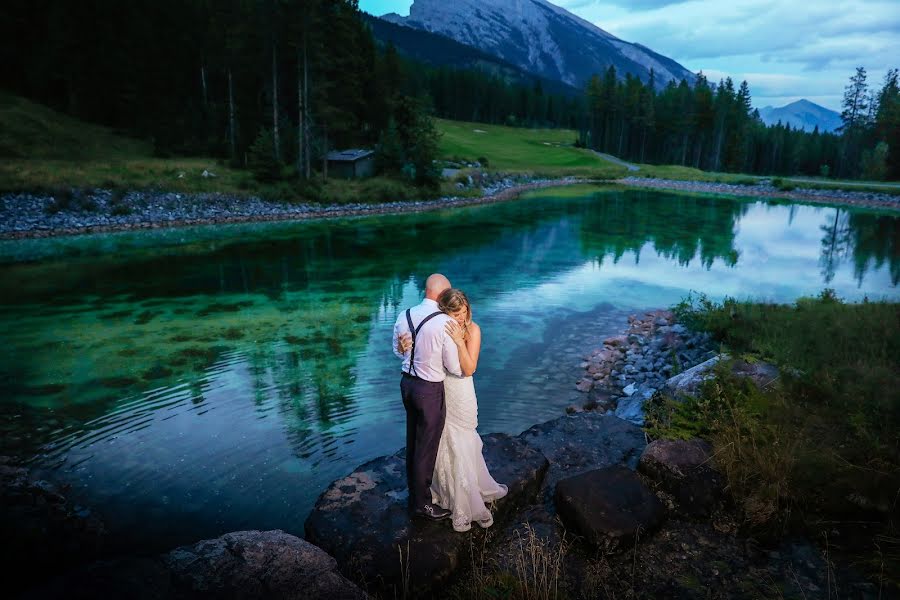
[431, 374, 508, 531]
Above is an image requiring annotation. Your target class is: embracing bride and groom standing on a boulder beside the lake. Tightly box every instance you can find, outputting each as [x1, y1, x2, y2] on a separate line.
[393, 273, 507, 531]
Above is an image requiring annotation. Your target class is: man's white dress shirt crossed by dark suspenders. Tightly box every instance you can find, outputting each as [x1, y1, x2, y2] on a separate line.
[392, 298, 462, 382]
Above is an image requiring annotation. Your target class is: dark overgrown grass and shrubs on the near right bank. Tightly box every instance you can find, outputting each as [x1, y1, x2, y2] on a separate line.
[648, 290, 900, 583]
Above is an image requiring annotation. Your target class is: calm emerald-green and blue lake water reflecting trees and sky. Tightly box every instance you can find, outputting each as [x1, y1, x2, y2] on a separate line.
[0, 187, 900, 549]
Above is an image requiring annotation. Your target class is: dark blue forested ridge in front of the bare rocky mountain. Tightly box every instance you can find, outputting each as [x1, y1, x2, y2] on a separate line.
[363, 13, 581, 97]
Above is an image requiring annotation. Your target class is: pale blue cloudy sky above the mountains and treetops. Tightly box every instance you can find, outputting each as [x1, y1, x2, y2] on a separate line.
[359, 0, 900, 112]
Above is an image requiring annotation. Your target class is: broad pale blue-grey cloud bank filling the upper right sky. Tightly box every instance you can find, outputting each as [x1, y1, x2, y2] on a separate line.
[563, 0, 900, 69]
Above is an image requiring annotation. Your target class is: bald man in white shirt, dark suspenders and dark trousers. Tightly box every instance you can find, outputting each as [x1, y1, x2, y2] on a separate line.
[393, 273, 462, 521]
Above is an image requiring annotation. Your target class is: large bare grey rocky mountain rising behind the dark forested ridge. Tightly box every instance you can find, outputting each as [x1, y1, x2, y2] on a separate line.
[382, 0, 694, 88]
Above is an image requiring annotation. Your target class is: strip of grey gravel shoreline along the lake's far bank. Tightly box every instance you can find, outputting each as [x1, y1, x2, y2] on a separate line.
[0, 177, 900, 239]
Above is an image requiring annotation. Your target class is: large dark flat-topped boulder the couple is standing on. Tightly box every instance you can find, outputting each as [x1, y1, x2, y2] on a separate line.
[306, 434, 548, 597]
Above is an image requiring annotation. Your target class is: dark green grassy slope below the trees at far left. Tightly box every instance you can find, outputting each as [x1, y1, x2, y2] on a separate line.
[0, 92, 152, 160]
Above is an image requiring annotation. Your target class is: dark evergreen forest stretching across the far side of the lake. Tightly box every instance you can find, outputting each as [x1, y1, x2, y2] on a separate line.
[0, 0, 900, 185]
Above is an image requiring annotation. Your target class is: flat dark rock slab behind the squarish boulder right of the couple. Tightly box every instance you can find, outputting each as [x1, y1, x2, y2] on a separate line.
[519, 412, 647, 500]
